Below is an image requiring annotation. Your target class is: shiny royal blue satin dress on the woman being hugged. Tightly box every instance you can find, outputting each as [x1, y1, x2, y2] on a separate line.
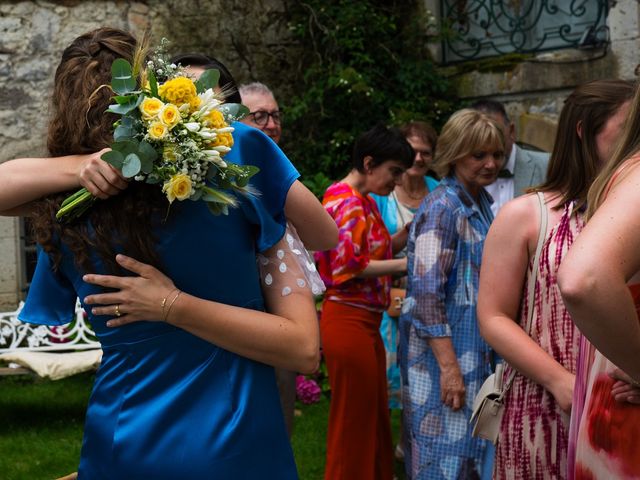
[20, 123, 298, 480]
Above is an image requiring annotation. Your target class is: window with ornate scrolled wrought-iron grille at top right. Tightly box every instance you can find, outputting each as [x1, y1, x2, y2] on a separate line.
[440, 0, 609, 63]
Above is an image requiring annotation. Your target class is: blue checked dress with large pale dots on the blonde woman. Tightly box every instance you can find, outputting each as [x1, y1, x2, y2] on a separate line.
[399, 176, 493, 480]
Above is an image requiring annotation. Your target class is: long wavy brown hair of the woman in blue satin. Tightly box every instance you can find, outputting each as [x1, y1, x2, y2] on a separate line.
[32, 28, 168, 273]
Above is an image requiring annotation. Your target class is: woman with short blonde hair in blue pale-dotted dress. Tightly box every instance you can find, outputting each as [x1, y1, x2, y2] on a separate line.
[400, 109, 504, 479]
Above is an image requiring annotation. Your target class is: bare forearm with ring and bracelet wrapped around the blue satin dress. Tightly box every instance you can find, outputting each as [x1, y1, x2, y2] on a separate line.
[84, 251, 320, 373]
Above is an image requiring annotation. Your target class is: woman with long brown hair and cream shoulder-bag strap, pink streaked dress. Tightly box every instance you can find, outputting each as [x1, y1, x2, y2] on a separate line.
[478, 80, 633, 480]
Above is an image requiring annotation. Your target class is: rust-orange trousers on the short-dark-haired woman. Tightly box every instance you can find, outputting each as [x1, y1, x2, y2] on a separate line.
[320, 300, 393, 480]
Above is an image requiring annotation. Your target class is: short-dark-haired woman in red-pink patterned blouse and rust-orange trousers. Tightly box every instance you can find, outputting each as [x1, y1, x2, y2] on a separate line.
[316, 126, 414, 480]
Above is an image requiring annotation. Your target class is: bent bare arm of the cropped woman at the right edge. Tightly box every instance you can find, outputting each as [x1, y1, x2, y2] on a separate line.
[558, 165, 640, 380]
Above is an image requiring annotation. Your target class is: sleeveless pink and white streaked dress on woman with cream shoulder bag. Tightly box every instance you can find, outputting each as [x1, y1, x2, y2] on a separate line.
[494, 204, 584, 480]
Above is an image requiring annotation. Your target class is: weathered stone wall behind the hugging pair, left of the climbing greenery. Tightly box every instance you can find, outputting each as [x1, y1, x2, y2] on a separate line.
[0, 0, 297, 309]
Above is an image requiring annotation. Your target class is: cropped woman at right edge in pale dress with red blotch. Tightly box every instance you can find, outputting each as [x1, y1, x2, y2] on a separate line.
[558, 81, 640, 480]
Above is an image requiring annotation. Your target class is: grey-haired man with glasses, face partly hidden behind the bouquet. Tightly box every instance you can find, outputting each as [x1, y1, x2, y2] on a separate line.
[238, 82, 282, 143]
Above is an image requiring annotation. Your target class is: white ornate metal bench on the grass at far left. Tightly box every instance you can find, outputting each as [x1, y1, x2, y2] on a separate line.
[0, 302, 101, 379]
